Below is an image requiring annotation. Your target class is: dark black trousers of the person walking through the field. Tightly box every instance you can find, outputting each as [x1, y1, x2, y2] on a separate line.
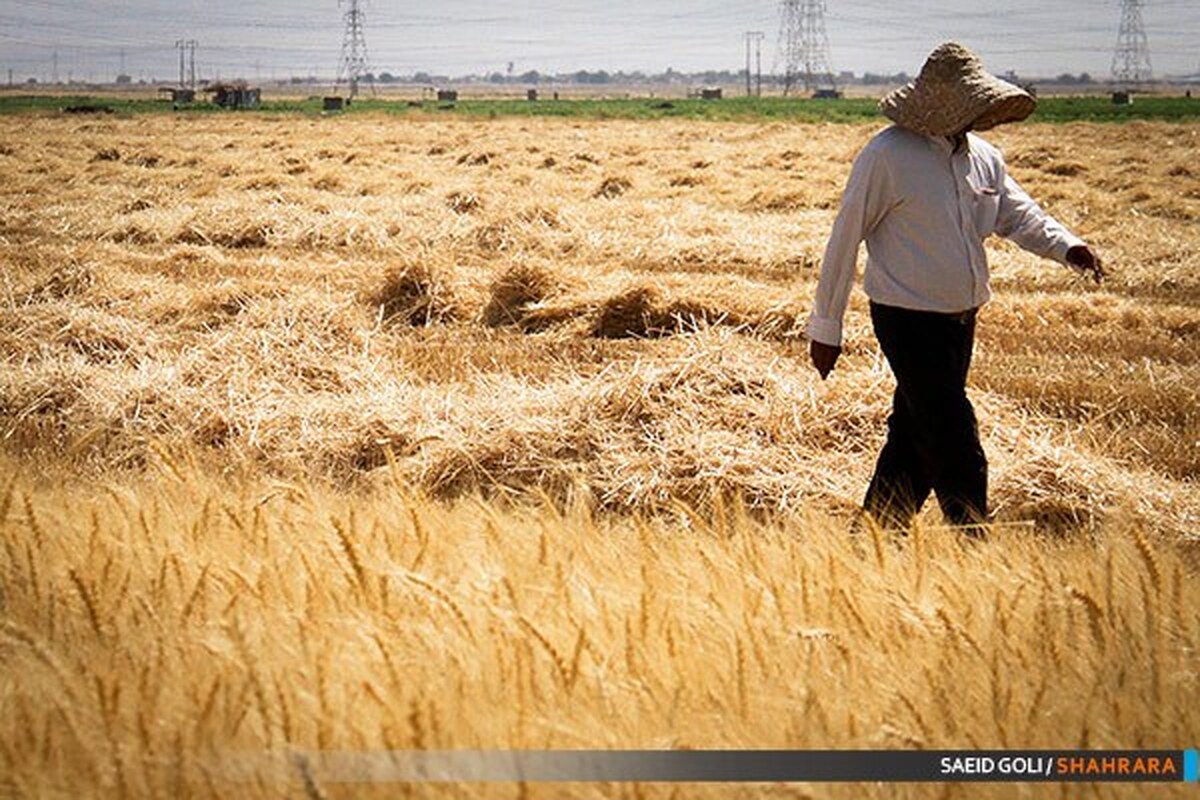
[863, 302, 988, 529]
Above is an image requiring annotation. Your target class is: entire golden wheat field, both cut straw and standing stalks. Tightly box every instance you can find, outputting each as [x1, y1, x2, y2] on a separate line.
[0, 115, 1200, 798]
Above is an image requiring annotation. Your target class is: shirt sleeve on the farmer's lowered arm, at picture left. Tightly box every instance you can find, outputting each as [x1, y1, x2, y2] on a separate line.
[806, 146, 892, 347]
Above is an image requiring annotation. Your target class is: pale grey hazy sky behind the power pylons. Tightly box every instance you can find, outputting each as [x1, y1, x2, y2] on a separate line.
[0, 0, 1200, 82]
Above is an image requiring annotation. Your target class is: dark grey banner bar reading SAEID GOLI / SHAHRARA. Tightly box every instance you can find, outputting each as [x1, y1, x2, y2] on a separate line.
[221, 750, 1184, 783]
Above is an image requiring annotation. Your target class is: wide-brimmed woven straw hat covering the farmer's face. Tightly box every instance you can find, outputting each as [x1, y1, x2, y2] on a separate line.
[880, 42, 1037, 136]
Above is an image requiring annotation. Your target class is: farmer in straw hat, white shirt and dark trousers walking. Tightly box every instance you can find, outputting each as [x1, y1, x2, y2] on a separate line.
[808, 42, 1104, 533]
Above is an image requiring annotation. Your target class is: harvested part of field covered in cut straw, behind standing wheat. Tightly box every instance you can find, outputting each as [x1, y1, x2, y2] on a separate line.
[0, 112, 1200, 531]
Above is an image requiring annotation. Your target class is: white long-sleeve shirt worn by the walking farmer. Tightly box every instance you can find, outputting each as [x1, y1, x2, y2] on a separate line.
[808, 126, 1082, 345]
